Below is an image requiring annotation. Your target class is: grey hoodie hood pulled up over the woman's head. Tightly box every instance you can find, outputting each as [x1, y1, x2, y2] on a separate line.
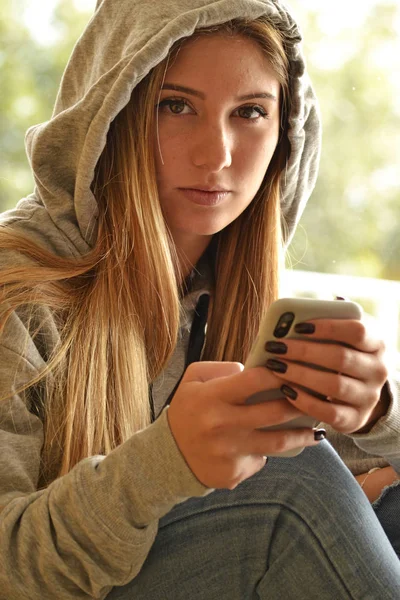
[2, 0, 321, 256]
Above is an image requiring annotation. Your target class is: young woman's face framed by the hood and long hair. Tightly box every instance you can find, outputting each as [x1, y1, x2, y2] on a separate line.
[154, 34, 280, 255]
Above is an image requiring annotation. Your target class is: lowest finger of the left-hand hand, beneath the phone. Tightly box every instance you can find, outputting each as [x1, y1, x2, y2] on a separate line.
[239, 429, 321, 456]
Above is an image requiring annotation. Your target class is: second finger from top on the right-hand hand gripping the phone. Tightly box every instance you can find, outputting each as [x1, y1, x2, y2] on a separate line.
[268, 339, 388, 382]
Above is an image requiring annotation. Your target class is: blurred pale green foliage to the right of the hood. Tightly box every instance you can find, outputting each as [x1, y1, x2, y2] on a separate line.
[290, 3, 400, 279]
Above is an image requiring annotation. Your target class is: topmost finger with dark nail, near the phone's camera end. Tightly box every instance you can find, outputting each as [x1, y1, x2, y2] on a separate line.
[296, 319, 384, 353]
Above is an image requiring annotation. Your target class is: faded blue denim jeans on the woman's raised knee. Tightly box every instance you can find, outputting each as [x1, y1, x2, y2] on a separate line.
[107, 441, 400, 600]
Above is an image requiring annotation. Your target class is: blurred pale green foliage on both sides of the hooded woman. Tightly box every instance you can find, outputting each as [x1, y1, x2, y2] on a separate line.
[0, 0, 400, 280]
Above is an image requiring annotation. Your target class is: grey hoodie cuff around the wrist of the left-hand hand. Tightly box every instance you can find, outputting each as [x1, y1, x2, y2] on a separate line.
[76, 407, 213, 542]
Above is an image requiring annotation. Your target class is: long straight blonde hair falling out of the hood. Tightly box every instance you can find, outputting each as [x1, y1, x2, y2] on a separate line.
[0, 18, 289, 485]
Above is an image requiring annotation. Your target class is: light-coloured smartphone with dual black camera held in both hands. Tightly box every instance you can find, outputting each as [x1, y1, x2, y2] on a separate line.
[244, 298, 363, 457]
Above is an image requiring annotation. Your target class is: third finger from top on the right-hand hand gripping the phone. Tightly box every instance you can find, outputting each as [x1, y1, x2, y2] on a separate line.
[267, 360, 368, 408]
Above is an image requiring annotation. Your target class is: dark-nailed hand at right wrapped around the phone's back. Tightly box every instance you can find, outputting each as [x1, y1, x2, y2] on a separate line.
[266, 319, 389, 433]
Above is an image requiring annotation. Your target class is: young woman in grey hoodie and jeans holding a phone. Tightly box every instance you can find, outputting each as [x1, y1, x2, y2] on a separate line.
[0, 0, 400, 600]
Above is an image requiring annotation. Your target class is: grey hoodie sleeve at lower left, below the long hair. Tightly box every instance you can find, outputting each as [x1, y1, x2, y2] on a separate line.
[0, 364, 211, 600]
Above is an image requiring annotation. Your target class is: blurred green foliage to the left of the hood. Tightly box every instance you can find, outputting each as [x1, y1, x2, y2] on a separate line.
[0, 0, 89, 211]
